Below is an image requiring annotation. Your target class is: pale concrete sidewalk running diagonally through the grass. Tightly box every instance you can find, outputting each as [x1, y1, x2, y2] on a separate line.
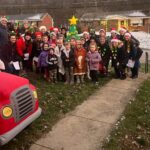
[30, 74, 147, 150]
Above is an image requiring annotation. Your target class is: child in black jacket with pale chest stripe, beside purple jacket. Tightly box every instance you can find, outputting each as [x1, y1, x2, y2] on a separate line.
[46, 47, 58, 83]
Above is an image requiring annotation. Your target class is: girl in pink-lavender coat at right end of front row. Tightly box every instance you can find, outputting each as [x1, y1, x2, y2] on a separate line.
[87, 44, 102, 84]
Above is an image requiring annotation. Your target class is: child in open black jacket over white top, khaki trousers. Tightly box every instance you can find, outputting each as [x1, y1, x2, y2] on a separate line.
[61, 42, 75, 84]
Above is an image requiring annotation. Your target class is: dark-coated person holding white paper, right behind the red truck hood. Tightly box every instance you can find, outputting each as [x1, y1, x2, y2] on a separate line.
[0, 32, 21, 75]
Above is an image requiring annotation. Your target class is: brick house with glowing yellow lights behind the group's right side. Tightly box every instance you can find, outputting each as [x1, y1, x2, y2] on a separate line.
[80, 11, 150, 32]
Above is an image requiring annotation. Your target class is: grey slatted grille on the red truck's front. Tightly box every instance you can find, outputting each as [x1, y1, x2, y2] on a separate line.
[11, 86, 35, 122]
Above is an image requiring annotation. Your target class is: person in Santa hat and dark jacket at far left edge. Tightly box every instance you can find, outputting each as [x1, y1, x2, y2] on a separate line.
[0, 16, 9, 47]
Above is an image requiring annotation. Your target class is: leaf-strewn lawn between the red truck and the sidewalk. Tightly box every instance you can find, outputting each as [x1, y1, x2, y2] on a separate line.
[0, 74, 111, 150]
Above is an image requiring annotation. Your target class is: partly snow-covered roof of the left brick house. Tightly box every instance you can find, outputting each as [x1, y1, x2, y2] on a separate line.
[8, 13, 49, 21]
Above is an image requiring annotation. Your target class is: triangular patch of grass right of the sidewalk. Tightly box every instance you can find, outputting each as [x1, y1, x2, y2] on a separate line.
[103, 78, 150, 150]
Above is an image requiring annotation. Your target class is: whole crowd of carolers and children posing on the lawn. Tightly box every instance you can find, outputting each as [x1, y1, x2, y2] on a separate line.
[0, 17, 142, 84]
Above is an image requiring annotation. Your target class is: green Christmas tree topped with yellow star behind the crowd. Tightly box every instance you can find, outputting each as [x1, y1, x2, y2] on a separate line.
[66, 16, 79, 41]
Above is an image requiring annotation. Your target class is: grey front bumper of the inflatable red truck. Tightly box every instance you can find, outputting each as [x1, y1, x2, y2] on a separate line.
[0, 108, 42, 146]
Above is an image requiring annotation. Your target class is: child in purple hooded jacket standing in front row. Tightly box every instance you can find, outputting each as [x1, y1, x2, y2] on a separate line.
[38, 43, 49, 80]
